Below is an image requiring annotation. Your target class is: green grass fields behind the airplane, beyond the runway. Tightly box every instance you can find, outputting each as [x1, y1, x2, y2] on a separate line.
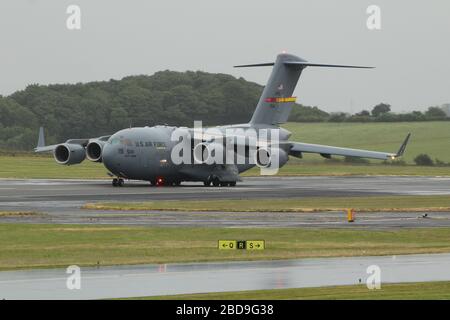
[0, 122, 450, 179]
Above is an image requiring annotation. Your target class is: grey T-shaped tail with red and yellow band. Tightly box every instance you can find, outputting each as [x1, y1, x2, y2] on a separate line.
[235, 53, 370, 125]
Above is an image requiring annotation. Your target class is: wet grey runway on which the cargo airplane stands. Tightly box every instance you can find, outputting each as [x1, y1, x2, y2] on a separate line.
[0, 176, 450, 228]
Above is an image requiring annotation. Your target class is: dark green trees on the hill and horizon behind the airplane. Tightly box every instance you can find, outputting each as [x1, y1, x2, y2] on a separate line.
[0, 70, 443, 150]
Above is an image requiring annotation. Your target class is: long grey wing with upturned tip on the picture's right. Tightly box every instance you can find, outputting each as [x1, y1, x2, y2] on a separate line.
[288, 133, 411, 160]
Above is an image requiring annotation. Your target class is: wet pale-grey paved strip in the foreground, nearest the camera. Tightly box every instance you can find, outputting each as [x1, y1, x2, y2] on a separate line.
[0, 254, 450, 299]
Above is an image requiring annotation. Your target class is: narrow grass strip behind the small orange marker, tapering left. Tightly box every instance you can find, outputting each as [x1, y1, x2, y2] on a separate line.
[83, 195, 450, 212]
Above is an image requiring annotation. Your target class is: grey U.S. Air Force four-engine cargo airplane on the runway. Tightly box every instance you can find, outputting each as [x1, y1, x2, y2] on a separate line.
[35, 53, 410, 186]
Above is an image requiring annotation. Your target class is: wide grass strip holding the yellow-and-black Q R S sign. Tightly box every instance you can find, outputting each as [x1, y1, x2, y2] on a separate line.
[0, 224, 450, 270]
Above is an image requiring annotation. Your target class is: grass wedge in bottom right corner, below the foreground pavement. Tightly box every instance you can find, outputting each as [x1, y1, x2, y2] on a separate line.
[134, 281, 450, 300]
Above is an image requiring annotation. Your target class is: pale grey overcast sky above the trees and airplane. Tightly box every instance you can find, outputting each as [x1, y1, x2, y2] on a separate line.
[0, 0, 450, 112]
